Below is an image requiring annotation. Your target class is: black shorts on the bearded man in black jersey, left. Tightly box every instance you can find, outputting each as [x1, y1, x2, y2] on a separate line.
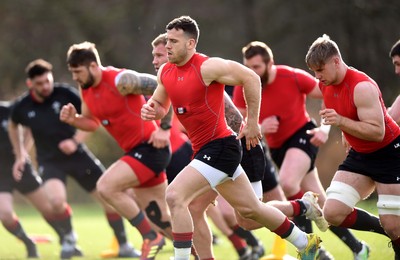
[39, 145, 105, 192]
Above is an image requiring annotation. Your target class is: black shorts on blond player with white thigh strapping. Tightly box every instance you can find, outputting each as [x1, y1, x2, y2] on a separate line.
[338, 136, 400, 184]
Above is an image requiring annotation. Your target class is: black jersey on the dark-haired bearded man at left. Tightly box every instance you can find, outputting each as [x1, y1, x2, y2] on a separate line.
[11, 83, 81, 162]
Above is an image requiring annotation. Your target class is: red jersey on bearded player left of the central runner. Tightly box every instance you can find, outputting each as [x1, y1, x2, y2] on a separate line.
[82, 67, 157, 152]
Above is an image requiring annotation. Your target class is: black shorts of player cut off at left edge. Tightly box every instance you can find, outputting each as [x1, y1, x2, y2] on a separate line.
[0, 157, 42, 194]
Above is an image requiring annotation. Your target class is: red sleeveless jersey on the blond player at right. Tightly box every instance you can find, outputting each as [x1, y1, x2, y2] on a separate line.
[319, 68, 400, 153]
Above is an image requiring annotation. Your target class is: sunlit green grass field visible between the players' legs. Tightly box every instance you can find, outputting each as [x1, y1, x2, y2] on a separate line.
[0, 200, 393, 260]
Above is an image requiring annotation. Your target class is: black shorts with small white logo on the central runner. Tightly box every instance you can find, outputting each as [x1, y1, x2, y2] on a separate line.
[194, 135, 242, 177]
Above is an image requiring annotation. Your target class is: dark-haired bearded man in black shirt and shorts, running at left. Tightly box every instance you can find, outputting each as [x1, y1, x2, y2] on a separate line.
[9, 59, 139, 259]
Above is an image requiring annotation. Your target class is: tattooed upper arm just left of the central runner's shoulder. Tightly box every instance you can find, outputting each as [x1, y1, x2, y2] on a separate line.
[115, 70, 157, 95]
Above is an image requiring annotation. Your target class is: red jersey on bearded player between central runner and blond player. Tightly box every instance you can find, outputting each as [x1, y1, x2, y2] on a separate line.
[233, 65, 317, 148]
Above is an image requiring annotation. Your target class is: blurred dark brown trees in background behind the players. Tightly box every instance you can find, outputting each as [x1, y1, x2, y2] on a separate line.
[0, 0, 400, 197]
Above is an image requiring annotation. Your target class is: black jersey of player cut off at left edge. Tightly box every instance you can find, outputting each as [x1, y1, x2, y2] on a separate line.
[0, 101, 14, 156]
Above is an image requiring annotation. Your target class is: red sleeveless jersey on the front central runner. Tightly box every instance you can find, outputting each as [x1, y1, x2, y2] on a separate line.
[160, 53, 233, 154]
